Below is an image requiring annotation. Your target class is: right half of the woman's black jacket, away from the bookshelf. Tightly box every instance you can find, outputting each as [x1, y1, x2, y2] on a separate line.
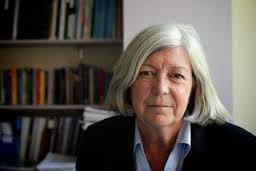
[184, 123, 256, 170]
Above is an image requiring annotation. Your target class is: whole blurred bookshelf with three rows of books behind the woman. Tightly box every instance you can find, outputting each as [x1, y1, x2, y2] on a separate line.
[0, 0, 123, 170]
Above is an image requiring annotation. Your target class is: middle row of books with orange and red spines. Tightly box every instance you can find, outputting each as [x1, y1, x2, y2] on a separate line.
[0, 64, 111, 105]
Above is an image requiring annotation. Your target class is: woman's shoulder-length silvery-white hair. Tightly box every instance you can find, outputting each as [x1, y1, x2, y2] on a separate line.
[106, 24, 228, 125]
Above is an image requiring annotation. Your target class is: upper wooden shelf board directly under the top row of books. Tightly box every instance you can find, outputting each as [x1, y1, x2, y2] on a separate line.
[0, 39, 123, 47]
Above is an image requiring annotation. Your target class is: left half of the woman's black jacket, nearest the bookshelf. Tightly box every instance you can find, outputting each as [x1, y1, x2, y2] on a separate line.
[76, 115, 134, 171]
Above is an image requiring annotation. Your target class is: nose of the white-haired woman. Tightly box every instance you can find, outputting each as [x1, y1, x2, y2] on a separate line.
[152, 75, 170, 96]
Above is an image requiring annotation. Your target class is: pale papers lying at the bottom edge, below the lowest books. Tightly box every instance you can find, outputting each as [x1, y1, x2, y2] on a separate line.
[37, 153, 76, 171]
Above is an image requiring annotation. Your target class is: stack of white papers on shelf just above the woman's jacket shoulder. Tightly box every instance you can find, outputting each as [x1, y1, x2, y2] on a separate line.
[83, 106, 117, 129]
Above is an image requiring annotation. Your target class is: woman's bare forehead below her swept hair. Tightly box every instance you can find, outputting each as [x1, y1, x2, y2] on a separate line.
[143, 47, 191, 69]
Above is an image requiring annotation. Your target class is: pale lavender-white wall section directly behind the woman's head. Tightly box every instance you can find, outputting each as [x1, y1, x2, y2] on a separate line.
[124, 0, 232, 112]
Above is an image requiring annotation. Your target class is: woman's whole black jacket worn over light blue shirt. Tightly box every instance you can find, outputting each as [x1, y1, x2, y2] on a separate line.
[76, 116, 256, 171]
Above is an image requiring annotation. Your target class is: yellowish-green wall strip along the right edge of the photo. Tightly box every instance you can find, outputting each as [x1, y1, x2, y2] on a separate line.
[232, 0, 256, 135]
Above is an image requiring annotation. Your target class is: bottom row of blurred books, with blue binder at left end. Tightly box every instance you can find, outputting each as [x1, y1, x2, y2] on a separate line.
[0, 116, 81, 165]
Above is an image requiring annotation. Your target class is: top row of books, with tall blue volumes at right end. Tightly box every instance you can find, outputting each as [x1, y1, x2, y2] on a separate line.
[0, 0, 123, 40]
